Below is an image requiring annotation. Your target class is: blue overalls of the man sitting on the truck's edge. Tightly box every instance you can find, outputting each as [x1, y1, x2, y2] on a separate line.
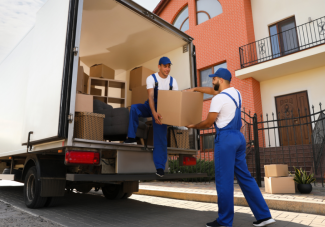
[128, 74, 173, 170]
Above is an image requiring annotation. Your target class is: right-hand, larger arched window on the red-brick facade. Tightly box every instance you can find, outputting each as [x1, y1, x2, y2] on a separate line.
[196, 0, 222, 25]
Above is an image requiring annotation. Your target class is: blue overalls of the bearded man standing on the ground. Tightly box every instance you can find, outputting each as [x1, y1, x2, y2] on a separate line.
[214, 91, 271, 226]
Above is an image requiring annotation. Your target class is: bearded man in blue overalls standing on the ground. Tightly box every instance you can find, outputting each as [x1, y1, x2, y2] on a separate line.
[188, 68, 275, 227]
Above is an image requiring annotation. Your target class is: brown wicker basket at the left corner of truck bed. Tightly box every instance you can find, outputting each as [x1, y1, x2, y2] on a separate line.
[74, 112, 105, 141]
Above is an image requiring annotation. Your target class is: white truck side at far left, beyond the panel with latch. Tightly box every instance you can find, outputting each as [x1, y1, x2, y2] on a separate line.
[0, 29, 34, 157]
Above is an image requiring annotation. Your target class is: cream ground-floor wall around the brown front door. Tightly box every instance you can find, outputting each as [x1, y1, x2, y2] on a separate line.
[260, 67, 325, 146]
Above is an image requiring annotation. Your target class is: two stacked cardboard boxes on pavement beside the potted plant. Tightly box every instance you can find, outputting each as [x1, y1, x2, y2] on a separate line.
[264, 164, 295, 194]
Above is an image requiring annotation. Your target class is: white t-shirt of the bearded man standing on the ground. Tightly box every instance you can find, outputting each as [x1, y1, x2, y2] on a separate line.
[209, 87, 242, 128]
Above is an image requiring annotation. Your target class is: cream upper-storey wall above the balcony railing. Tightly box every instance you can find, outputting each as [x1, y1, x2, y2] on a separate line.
[251, 0, 325, 40]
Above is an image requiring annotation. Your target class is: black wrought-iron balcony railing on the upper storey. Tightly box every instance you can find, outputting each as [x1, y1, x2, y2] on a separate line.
[239, 16, 325, 68]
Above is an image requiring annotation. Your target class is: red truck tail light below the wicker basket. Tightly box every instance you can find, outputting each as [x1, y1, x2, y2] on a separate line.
[65, 151, 100, 165]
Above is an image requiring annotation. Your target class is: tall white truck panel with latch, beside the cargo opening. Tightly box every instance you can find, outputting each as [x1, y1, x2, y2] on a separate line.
[21, 0, 69, 143]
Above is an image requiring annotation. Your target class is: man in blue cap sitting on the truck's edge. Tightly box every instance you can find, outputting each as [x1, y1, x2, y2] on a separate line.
[124, 57, 178, 177]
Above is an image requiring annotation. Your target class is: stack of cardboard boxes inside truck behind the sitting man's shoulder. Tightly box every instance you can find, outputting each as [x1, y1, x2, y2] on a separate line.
[129, 66, 155, 105]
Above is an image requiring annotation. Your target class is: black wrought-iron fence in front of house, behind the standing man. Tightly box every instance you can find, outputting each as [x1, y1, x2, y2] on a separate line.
[169, 104, 325, 187]
